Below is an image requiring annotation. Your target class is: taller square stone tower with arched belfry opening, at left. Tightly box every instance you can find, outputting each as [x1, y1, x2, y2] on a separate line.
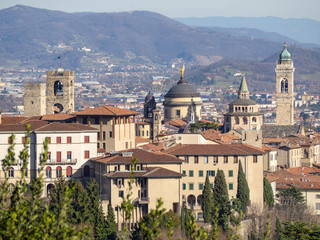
[47, 66, 74, 114]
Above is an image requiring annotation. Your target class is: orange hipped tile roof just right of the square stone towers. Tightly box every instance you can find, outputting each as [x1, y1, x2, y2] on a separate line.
[74, 106, 140, 116]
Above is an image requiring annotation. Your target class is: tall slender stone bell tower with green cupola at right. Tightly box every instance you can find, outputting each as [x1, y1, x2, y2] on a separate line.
[275, 43, 294, 125]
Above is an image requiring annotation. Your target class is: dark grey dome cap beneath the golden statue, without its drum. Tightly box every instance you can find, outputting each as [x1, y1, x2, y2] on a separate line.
[164, 77, 200, 98]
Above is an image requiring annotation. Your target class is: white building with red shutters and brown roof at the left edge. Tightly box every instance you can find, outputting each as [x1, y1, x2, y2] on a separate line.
[0, 121, 97, 196]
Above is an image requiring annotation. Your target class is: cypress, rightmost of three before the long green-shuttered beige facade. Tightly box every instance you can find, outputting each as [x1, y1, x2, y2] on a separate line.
[237, 161, 250, 213]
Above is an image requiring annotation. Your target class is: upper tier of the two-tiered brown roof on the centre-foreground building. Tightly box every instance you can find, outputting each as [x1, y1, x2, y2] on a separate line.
[91, 149, 184, 165]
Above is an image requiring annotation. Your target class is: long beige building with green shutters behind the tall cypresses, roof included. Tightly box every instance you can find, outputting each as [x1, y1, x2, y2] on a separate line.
[166, 144, 264, 219]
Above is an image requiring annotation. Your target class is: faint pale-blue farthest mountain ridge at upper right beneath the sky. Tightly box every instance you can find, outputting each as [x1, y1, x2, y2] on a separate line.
[175, 17, 320, 44]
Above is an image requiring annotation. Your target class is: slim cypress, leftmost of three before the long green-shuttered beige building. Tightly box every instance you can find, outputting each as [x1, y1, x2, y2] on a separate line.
[201, 173, 213, 223]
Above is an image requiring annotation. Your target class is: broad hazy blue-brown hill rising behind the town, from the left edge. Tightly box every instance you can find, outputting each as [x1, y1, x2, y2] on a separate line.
[0, 5, 304, 70]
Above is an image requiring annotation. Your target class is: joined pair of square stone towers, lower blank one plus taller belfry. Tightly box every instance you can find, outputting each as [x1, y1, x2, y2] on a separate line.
[24, 67, 74, 117]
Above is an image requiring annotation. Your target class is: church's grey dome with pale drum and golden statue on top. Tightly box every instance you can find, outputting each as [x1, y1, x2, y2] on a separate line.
[163, 66, 202, 122]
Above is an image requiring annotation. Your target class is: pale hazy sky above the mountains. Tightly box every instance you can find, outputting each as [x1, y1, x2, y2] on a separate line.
[0, 0, 320, 21]
